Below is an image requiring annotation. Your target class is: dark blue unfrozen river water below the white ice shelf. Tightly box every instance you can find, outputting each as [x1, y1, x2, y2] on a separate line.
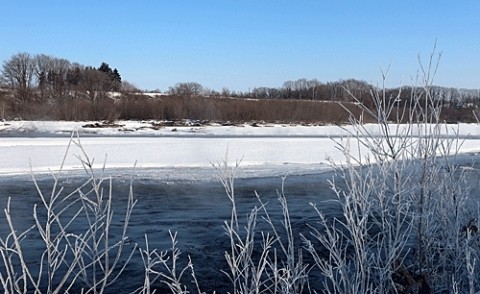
[0, 172, 339, 293]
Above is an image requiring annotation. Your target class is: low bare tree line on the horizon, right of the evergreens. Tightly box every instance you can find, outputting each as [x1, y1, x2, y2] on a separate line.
[166, 78, 480, 109]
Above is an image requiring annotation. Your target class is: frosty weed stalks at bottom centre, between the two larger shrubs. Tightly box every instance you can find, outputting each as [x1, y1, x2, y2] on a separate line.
[216, 159, 310, 294]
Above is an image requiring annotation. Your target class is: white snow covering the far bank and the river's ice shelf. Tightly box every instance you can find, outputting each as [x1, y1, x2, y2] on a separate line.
[0, 121, 480, 175]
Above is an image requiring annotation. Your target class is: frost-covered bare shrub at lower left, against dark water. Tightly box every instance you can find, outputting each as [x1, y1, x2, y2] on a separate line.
[0, 136, 136, 293]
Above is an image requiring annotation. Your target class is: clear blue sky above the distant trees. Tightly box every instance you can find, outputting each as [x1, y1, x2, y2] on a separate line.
[0, 0, 480, 91]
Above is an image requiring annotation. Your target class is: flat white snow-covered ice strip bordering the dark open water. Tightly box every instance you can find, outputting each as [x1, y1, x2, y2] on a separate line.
[0, 137, 339, 174]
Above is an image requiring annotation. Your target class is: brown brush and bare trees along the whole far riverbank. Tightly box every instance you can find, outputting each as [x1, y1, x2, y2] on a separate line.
[0, 52, 480, 124]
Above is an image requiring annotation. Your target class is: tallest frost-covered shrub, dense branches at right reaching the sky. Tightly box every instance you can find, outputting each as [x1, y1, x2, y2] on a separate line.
[304, 46, 480, 293]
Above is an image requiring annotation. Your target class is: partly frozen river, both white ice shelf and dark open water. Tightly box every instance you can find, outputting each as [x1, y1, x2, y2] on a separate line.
[0, 136, 346, 293]
